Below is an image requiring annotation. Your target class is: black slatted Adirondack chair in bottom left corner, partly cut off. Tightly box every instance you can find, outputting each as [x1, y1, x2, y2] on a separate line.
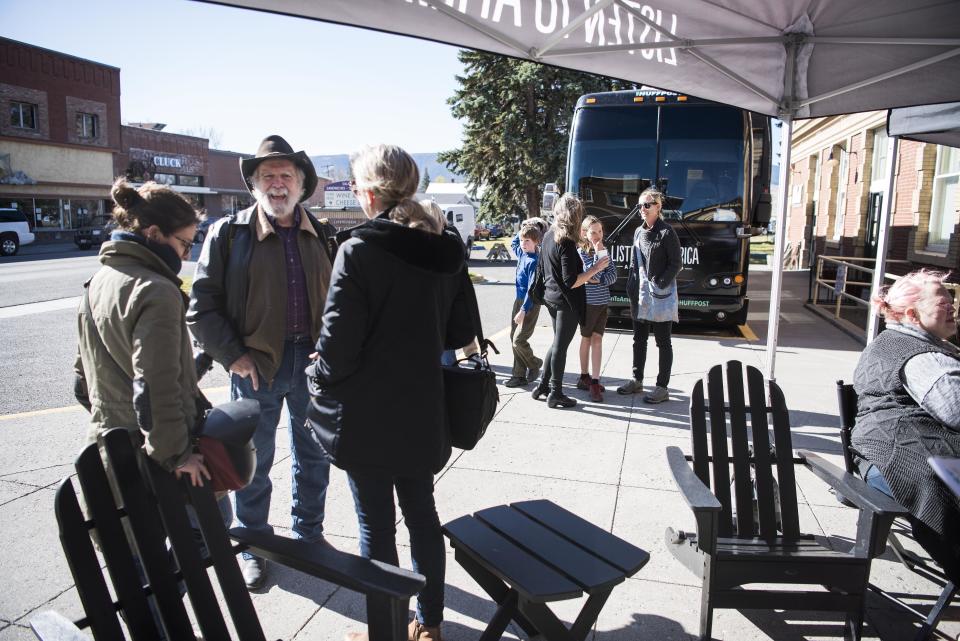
[31, 429, 425, 641]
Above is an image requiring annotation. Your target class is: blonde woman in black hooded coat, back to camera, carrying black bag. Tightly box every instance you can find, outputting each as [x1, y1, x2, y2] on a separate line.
[307, 145, 474, 641]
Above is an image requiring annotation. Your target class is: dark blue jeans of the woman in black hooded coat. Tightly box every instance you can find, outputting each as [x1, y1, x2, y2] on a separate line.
[347, 471, 447, 626]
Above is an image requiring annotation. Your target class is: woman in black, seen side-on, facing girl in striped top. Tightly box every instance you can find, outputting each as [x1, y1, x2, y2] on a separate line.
[533, 193, 610, 408]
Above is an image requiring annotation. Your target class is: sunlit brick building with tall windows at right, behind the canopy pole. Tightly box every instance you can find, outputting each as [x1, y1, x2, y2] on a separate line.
[787, 111, 960, 273]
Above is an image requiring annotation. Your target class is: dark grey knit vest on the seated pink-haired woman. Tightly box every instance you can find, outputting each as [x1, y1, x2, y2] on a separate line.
[852, 329, 960, 534]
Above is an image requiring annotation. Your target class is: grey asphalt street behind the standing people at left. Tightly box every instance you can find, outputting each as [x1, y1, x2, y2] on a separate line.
[0, 244, 515, 418]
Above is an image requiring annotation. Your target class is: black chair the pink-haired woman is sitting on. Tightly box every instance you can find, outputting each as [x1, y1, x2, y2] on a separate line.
[837, 381, 957, 641]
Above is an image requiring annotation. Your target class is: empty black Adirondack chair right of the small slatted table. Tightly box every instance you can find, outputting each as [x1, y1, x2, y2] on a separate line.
[666, 361, 904, 640]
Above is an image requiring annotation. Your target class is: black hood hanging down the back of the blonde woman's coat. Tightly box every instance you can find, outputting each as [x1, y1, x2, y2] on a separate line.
[337, 218, 466, 274]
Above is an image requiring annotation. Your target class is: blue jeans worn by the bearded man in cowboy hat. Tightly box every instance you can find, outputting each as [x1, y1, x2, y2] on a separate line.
[230, 338, 330, 558]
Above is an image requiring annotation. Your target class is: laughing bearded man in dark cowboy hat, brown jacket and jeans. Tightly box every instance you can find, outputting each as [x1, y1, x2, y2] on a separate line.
[187, 136, 333, 589]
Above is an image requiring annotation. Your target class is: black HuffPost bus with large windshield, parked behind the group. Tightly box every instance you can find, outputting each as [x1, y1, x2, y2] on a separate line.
[565, 88, 771, 326]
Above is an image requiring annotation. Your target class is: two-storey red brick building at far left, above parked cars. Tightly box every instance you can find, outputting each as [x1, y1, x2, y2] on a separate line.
[0, 38, 121, 242]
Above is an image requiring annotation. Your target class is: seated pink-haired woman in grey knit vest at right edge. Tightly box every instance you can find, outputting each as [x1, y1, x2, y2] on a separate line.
[853, 270, 960, 583]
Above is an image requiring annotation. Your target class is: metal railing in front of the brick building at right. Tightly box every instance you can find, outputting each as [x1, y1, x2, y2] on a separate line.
[812, 256, 960, 331]
